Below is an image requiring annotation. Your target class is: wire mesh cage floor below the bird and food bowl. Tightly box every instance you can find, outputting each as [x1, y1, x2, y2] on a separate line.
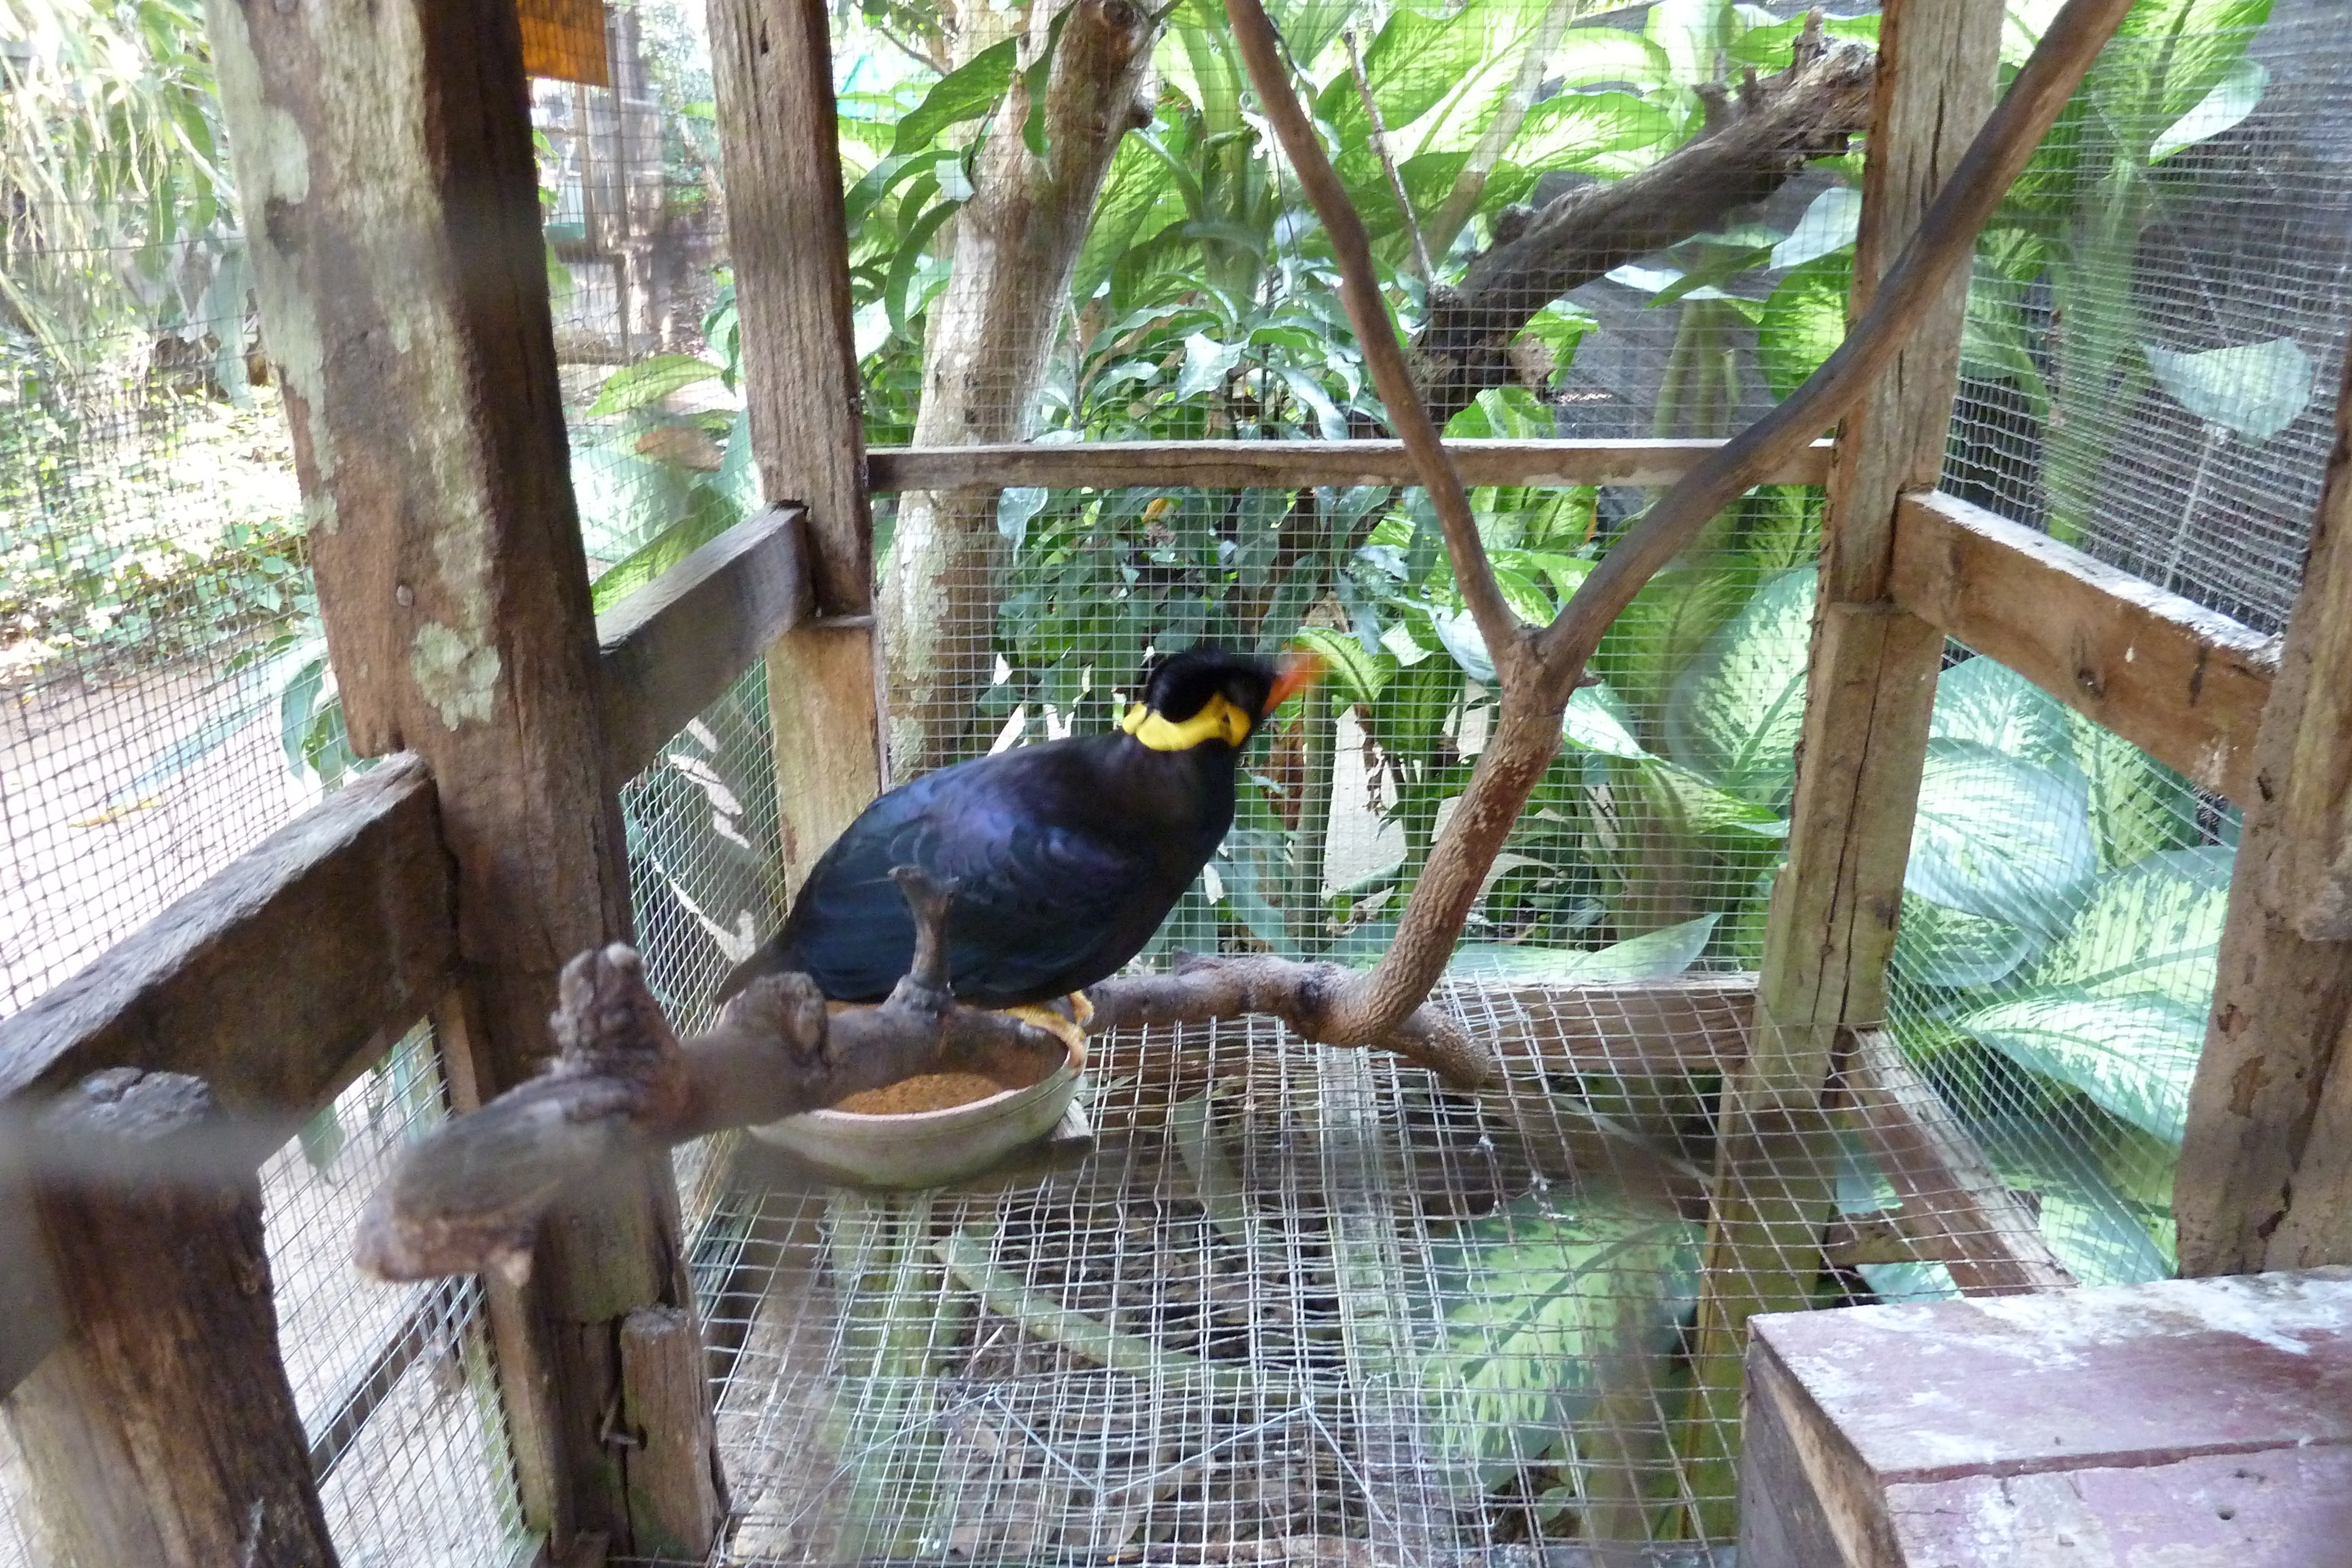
[673, 980, 1748, 1563]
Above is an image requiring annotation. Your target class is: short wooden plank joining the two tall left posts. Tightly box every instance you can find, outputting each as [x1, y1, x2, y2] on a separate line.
[595, 508, 809, 790]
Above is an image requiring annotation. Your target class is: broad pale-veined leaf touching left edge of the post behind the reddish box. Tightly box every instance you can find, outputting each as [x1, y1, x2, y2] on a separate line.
[1665, 567, 1813, 806]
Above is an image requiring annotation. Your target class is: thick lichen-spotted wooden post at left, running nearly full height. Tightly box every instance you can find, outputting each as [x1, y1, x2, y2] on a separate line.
[209, 0, 715, 1552]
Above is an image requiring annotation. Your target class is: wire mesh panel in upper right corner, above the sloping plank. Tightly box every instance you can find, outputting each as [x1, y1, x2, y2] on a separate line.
[1945, 0, 2352, 630]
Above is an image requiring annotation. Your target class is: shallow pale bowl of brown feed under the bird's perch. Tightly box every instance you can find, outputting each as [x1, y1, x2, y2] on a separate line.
[750, 1034, 1080, 1189]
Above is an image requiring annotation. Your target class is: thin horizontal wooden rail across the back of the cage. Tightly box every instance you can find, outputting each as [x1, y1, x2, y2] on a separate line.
[866, 440, 1835, 494]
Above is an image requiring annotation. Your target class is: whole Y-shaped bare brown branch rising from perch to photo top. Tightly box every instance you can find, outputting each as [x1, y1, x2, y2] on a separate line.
[1204, 0, 2129, 1062]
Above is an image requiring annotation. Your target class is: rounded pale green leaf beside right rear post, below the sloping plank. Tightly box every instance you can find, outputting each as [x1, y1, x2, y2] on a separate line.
[1903, 741, 2098, 935]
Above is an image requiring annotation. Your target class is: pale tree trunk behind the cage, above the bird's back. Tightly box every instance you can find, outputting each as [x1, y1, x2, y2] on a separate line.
[882, 0, 1157, 778]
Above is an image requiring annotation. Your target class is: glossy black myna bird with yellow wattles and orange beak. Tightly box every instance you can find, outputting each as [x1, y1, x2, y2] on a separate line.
[717, 647, 1322, 1053]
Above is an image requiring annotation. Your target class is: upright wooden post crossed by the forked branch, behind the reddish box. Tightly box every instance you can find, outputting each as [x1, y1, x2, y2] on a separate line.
[1686, 0, 2002, 1535]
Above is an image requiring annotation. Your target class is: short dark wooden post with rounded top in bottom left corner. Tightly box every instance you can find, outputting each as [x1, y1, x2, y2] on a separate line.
[0, 1067, 334, 1568]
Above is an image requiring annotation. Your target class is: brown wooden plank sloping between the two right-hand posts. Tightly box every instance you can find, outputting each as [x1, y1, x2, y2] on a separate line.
[1891, 492, 2277, 806]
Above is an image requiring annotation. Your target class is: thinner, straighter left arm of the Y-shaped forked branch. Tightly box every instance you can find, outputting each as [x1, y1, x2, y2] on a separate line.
[1225, 0, 1529, 677]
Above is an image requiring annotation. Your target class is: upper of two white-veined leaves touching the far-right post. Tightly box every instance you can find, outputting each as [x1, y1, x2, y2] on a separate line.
[2032, 844, 2232, 1011]
